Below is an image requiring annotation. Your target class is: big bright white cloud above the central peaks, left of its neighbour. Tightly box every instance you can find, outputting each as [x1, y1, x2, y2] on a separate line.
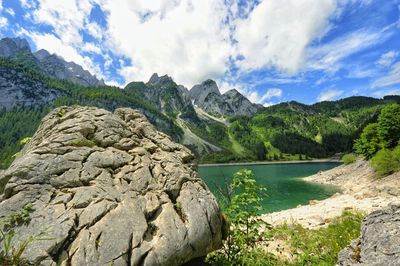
[97, 0, 232, 87]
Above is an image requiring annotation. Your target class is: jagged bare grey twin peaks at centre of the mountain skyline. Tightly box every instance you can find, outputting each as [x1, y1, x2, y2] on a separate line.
[189, 80, 263, 117]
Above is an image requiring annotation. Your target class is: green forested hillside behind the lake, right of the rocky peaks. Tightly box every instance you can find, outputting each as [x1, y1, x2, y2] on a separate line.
[200, 96, 400, 161]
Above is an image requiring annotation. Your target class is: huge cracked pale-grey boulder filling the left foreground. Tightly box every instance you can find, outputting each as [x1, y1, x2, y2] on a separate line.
[0, 107, 223, 266]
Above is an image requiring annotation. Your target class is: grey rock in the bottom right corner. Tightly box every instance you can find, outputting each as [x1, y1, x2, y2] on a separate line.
[338, 205, 400, 266]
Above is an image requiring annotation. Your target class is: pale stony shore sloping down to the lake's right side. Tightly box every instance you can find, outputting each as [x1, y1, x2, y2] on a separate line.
[263, 160, 400, 228]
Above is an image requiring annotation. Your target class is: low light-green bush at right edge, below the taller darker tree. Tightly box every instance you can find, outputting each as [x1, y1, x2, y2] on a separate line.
[370, 147, 400, 177]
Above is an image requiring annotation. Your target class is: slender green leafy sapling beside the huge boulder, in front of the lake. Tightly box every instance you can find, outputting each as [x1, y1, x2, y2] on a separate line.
[208, 169, 273, 265]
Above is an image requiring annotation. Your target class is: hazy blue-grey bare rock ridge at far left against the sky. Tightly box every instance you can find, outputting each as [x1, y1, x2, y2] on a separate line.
[0, 38, 105, 86]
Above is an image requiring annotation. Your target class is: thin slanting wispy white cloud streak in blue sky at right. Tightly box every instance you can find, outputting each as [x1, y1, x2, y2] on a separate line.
[307, 30, 386, 73]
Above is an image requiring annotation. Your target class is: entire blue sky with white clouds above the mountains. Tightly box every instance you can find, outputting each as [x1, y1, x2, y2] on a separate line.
[0, 0, 400, 106]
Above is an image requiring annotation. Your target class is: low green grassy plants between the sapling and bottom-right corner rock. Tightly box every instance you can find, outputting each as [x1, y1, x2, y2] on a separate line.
[271, 211, 364, 266]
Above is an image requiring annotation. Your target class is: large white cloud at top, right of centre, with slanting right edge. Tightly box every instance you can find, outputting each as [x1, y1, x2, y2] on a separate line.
[235, 0, 337, 73]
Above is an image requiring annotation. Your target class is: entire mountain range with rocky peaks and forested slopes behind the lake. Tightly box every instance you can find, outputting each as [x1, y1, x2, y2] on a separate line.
[0, 38, 400, 167]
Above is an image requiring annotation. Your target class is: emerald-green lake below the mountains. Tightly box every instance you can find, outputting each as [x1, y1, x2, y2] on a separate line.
[198, 162, 340, 213]
